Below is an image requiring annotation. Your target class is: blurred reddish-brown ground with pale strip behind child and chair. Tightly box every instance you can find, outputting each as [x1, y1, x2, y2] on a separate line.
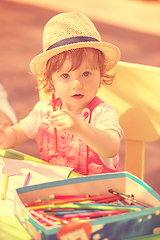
[0, 0, 160, 194]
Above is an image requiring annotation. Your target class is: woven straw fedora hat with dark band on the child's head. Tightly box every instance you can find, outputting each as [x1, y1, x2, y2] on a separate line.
[30, 12, 120, 75]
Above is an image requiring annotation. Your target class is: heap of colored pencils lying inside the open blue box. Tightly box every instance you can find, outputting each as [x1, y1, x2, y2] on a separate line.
[25, 189, 150, 227]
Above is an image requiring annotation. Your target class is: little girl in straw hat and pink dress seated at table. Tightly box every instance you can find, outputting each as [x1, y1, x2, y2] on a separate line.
[0, 12, 123, 175]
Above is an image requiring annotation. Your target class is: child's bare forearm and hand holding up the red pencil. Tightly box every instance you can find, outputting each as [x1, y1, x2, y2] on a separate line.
[51, 110, 120, 158]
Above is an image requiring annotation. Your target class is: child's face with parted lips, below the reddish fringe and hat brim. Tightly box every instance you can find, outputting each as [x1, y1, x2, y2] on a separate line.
[52, 53, 103, 113]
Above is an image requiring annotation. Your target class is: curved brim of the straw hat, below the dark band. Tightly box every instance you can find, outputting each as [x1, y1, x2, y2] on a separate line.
[30, 42, 120, 76]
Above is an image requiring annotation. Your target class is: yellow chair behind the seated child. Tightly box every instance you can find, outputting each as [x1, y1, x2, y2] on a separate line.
[39, 62, 160, 180]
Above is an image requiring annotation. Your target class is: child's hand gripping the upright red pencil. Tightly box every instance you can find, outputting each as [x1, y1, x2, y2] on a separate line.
[50, 109, 81, 135]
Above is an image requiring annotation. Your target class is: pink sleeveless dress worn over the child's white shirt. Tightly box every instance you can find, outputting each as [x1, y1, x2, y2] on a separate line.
[36, 97, 121, 175]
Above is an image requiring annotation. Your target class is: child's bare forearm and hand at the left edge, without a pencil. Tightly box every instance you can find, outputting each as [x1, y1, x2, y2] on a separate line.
[0, 121, 29, 149]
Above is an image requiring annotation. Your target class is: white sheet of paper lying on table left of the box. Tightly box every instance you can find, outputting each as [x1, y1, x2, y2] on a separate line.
[0, 157, 72, 216]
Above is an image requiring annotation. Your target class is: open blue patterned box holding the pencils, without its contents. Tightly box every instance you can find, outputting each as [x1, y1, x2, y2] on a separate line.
[15, 172, 160, 240]
